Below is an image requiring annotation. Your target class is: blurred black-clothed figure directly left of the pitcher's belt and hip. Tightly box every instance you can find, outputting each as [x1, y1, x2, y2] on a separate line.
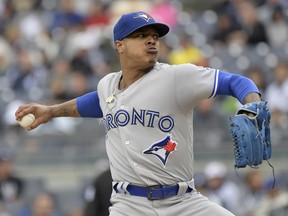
[84, 169, 112, 216]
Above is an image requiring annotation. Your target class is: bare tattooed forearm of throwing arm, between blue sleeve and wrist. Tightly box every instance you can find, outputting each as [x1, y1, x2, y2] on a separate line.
[50, 99, 80, 118]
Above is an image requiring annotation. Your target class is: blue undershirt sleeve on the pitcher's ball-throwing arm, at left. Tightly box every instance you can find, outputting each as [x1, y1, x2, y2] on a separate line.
[76, 91, 103, 118]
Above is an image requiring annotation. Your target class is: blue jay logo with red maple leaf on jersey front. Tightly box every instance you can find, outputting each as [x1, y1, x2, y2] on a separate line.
[143, 134, 177, 167]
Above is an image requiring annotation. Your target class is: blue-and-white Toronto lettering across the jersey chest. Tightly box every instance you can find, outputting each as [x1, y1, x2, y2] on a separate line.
[105, 108, 174, 132]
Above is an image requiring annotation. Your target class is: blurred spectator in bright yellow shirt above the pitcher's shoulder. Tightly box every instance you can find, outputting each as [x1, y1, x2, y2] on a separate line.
[168, 33, 208, 67]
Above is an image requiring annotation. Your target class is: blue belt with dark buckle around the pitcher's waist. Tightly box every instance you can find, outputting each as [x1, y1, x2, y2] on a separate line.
[114, 184, 193, 200]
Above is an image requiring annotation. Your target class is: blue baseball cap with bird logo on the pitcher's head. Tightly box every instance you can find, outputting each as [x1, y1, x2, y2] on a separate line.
[113, 11, 169, 42]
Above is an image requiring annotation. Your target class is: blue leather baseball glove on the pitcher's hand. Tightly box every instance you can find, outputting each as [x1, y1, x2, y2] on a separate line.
[230, 101, 271, 168]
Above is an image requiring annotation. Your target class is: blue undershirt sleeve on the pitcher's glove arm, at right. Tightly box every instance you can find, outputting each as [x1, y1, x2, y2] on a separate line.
[215, 71, 260, 103]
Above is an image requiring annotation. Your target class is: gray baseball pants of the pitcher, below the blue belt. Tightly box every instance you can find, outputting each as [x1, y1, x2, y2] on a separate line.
[109, 186, 234, 216]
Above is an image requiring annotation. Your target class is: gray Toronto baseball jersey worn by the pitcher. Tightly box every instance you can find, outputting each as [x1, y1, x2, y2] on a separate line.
[98, 63, 217, 186]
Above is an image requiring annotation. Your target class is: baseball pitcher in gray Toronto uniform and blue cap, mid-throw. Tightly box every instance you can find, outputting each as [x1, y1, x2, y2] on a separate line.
[16, 11, 271, 216]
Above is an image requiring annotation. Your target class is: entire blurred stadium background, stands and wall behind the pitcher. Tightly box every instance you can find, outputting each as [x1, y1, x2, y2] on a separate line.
[0, 0, 288, 216]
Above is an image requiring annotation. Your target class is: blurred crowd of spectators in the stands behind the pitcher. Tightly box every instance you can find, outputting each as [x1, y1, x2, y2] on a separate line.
[0, 0, 288, 216]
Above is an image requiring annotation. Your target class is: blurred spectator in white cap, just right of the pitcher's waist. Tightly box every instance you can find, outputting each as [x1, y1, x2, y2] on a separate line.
[204, 161, 240, 215]
